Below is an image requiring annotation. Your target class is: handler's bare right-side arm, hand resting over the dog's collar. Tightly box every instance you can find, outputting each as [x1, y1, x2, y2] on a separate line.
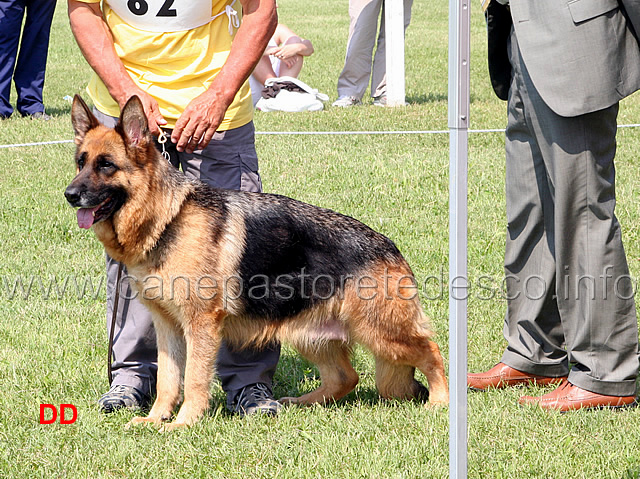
[171, 0, 278, 153]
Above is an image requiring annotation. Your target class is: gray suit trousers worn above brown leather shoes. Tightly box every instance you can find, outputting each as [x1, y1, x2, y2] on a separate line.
[502, 30, 639, 396]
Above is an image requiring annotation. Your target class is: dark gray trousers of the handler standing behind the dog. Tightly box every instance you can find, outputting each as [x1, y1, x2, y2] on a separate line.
[94, 111, 280, 404]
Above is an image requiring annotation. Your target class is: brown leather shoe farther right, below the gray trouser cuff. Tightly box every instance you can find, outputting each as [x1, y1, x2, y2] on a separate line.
[519, 380, 637, 412]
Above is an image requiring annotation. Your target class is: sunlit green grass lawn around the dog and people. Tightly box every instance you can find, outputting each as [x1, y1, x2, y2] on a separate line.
[0, 0, 640, 479]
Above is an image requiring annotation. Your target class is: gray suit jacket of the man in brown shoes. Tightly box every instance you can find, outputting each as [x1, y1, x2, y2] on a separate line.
[487, 0, 640, 117]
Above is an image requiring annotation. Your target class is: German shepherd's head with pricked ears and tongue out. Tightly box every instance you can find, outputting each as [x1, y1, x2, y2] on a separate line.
[64, 95, 154, 228]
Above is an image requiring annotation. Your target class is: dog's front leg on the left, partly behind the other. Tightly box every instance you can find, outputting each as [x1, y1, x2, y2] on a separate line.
[126, 317, 186, 428]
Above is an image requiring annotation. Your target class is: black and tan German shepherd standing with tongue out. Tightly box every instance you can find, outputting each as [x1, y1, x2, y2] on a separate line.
[65, 96, 449, 430]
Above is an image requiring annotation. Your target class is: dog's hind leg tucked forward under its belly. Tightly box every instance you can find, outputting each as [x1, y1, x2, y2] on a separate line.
[280, 340, 359, 405]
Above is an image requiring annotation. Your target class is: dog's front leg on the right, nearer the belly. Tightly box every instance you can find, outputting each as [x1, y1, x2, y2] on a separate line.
[163, 311, 224, 431]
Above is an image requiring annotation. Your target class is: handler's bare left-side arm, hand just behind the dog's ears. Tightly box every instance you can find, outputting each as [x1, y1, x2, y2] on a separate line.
[68, 0, 167, 135]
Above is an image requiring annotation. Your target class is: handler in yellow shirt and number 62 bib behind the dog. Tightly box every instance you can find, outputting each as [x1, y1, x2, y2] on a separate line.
[68, 0, 280, 415]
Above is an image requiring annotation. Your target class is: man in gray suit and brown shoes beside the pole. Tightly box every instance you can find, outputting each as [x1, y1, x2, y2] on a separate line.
[467, 0, 640, 411]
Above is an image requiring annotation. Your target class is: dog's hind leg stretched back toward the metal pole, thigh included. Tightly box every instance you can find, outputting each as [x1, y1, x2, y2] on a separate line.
[342, 264, 449, 404]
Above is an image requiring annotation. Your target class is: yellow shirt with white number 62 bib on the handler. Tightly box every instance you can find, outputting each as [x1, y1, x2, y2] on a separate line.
[80, 0, 253, 130]
